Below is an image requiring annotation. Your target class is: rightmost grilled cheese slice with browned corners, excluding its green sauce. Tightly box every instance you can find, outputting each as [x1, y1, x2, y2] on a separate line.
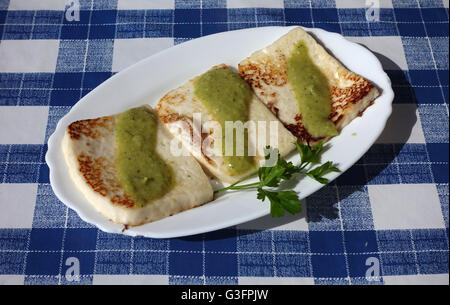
[239, 27, 379, 144]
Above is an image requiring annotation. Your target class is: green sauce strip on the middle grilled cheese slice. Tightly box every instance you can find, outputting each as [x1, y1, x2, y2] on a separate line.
[194, 69, 255, 176]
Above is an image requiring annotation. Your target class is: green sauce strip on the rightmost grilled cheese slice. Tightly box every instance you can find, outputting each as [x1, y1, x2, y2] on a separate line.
[287, 41, 338, 138]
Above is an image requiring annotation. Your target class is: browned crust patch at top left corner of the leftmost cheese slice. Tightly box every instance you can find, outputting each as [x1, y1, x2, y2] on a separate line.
[67, 116, 114, 140]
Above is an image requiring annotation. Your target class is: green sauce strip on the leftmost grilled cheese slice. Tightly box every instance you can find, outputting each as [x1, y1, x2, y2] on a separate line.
[115, 107, 173, 208]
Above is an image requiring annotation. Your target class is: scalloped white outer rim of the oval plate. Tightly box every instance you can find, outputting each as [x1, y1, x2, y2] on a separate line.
[45, 26, 394, 238]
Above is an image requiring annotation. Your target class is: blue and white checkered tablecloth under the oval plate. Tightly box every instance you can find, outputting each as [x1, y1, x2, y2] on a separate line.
[0, 0, 449, 284]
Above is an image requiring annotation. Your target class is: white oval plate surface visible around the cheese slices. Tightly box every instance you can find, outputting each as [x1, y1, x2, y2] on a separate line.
[45, 27, 394, 238]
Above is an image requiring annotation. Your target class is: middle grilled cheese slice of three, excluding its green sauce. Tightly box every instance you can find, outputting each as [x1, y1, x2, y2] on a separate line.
[156, 64, 296, 183]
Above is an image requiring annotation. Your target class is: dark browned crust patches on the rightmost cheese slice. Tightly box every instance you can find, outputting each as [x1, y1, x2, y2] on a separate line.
[239, 58, 374, 143]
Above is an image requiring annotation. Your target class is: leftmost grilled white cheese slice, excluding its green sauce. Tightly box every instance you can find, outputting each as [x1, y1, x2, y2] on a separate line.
[62, 106, 213, 226]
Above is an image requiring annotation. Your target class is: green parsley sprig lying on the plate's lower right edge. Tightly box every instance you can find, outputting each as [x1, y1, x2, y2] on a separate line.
[214, 142, 339, 217]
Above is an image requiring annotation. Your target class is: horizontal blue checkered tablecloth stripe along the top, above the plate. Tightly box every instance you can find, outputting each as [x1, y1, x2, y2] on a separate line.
[0, 0, 448, 40]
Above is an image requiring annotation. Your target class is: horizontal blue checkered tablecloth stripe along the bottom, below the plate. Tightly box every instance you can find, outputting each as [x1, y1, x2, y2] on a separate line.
[0, 224, 448, 284]
